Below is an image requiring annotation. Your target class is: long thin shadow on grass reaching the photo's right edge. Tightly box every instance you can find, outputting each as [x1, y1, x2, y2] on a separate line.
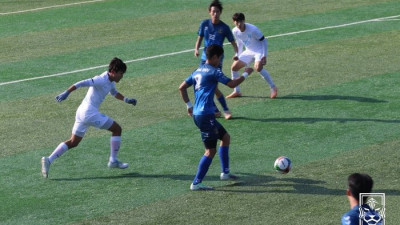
[231, 116, 400, 124]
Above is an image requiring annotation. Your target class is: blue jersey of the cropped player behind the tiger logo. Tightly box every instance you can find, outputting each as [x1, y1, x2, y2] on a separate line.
[342, 204, 382, 225]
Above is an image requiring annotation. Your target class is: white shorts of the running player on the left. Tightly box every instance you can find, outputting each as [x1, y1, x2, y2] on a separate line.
[72, 106, 114, 137]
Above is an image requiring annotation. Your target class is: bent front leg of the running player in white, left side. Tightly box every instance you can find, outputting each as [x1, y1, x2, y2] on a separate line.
[102, 118, 129, 169]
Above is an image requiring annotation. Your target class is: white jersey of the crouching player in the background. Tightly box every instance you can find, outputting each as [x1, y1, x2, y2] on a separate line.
[232, 23, 267, 56]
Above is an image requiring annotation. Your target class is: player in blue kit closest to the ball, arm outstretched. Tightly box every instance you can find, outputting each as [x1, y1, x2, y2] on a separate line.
[179, 44, 253, 190]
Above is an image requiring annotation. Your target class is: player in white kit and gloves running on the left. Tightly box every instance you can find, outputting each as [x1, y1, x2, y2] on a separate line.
[41, 58, 137, 178]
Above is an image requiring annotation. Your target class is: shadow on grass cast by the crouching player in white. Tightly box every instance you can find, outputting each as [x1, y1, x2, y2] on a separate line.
[279, 95, 387, 103]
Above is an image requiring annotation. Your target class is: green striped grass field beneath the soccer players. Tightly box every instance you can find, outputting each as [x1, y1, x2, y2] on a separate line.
[0, 0, 400, 225]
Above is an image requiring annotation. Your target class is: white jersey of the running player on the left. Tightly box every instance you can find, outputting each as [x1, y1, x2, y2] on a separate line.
[80, 71, 118, 110]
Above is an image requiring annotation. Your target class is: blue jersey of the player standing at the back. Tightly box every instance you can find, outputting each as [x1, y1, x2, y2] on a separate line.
[197, 19, 235, 61]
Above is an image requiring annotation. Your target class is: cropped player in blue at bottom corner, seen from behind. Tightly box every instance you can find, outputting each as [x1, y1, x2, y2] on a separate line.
[342, 173, 382, 225]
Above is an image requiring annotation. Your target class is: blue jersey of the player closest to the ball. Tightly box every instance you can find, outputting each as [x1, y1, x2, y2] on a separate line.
[185, 64, 231, 115]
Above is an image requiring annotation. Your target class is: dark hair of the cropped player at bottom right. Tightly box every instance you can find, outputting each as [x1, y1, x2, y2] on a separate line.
[347, 173, 374, 201]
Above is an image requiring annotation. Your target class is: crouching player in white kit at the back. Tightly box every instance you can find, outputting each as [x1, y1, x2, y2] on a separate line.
[227, 13, 278, 98]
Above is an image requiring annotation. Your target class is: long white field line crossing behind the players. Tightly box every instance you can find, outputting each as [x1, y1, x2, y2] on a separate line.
[0, 15, 400, 86]
